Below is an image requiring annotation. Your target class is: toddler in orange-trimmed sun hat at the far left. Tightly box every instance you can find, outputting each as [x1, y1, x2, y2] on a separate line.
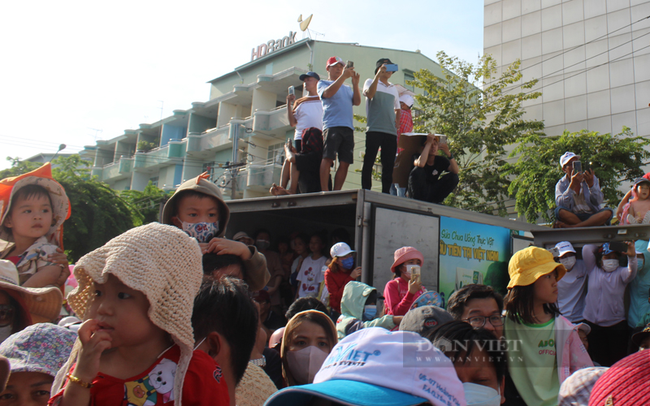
[0, 163, 70, 288]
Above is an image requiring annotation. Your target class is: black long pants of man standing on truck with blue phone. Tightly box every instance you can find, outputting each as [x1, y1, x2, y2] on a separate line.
[361, 131, 397, 193]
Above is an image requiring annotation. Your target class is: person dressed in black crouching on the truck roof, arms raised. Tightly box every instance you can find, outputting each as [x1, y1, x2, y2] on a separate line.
[408, 134, 460, 204]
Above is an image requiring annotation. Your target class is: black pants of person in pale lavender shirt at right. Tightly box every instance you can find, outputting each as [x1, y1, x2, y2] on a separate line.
[587, 320, 630, 367]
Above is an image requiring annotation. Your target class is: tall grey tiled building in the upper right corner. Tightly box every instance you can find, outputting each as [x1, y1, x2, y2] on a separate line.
[484, 0, 650, 136]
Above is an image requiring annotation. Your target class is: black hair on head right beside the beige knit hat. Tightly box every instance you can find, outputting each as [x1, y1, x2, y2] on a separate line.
[192, 277, 259, 383]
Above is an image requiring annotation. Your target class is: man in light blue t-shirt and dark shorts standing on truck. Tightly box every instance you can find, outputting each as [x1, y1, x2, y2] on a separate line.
[318, 56, 361, 191]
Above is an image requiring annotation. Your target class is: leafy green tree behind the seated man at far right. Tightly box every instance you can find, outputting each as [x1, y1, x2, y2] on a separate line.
[504, 127, 650, 223]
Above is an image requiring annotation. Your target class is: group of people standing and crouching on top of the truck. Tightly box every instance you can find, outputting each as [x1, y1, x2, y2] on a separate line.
[270, 56, 460, 203]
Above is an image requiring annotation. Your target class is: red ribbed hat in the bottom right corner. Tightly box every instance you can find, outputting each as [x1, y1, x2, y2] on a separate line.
[589, 350, 650, 406]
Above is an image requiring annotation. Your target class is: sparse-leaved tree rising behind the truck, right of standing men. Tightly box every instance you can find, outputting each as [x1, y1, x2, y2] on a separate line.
[409, 52, 544, 216]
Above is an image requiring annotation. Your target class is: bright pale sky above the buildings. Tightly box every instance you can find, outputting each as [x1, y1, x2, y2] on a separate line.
[0, 0, 483, 169]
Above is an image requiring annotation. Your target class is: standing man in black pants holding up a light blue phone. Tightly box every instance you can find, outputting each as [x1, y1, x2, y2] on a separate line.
[361, 58, 401, 193]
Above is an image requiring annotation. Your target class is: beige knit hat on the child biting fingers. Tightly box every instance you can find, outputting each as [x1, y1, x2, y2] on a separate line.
[53, 223, 203, 406]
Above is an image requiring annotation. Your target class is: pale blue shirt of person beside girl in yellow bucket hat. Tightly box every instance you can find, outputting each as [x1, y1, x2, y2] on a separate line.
[557, 259, 587, 323]
